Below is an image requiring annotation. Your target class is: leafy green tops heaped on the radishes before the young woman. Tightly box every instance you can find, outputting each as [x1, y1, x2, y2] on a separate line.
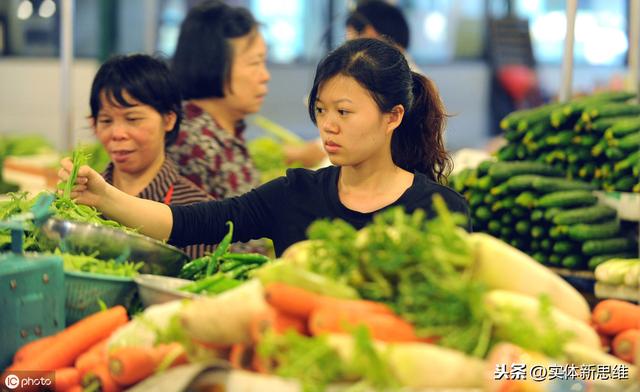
[306, 196, 568, 357]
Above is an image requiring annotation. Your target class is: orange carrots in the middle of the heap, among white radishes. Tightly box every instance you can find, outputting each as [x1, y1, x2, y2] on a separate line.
[229, 283, 428, 373]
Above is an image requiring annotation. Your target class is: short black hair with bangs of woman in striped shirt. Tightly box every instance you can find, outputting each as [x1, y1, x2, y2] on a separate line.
[89, 54, 182, 146]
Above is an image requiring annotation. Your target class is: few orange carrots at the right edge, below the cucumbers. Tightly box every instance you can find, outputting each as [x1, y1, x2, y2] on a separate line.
[591, 299, 640, 363]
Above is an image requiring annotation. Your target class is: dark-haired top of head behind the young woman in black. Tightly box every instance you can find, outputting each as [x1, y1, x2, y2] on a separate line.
[346, 0, 409, 50]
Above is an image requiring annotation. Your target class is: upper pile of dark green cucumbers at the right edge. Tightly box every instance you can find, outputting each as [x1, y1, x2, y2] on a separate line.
[497, 92, 640, 192]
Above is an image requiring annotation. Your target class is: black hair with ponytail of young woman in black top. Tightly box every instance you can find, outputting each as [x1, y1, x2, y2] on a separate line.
[309, 38, 452, 183]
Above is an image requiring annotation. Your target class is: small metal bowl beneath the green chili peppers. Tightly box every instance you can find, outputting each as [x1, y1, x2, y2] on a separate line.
[133, 274, 198, 307]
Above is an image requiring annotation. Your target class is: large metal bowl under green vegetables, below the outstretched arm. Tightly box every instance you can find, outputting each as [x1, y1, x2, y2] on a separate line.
[40, 218, 190, 276]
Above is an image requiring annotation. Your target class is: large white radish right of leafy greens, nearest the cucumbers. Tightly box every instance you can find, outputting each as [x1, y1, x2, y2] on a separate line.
[469, 233, 591, 323]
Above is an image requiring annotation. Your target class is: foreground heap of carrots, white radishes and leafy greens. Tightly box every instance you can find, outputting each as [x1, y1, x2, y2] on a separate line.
[5, 194, 636, 390]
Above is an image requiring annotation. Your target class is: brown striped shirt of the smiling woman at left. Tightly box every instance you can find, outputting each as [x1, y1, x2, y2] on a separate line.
[102, 158, 216, 258]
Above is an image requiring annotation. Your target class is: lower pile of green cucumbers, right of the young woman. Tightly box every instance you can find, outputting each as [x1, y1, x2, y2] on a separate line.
[450, 161, 638, 269]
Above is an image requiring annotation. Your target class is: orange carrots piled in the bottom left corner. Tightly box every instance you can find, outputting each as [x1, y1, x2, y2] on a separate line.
[7, 306, 187, 392]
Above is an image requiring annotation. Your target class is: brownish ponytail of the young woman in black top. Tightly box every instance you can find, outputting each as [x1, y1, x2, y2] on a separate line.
[391, 72, 453, 184]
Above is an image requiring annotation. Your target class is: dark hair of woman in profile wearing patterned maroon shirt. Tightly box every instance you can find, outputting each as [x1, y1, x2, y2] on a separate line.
[172, 0, 258, 99]
